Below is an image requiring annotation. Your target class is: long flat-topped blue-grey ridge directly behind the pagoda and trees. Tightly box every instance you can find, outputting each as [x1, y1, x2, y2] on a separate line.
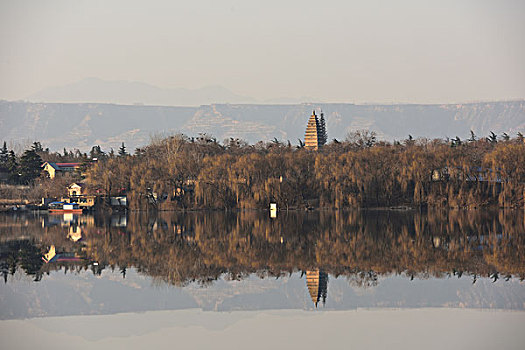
[0, 99, 525, 150]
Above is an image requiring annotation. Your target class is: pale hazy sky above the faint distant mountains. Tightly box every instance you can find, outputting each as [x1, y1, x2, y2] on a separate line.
[0, 0, 525, 102]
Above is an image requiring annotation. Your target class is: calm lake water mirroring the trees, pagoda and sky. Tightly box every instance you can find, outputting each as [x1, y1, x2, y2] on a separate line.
[0, 210, 525, 349]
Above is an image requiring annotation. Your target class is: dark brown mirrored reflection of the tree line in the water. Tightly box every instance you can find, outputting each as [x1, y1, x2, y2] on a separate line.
[0, 211, 525, 286]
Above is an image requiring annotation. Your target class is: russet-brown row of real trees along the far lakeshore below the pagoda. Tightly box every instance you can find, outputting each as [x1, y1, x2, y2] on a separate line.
[0, 130, 525, 210]
